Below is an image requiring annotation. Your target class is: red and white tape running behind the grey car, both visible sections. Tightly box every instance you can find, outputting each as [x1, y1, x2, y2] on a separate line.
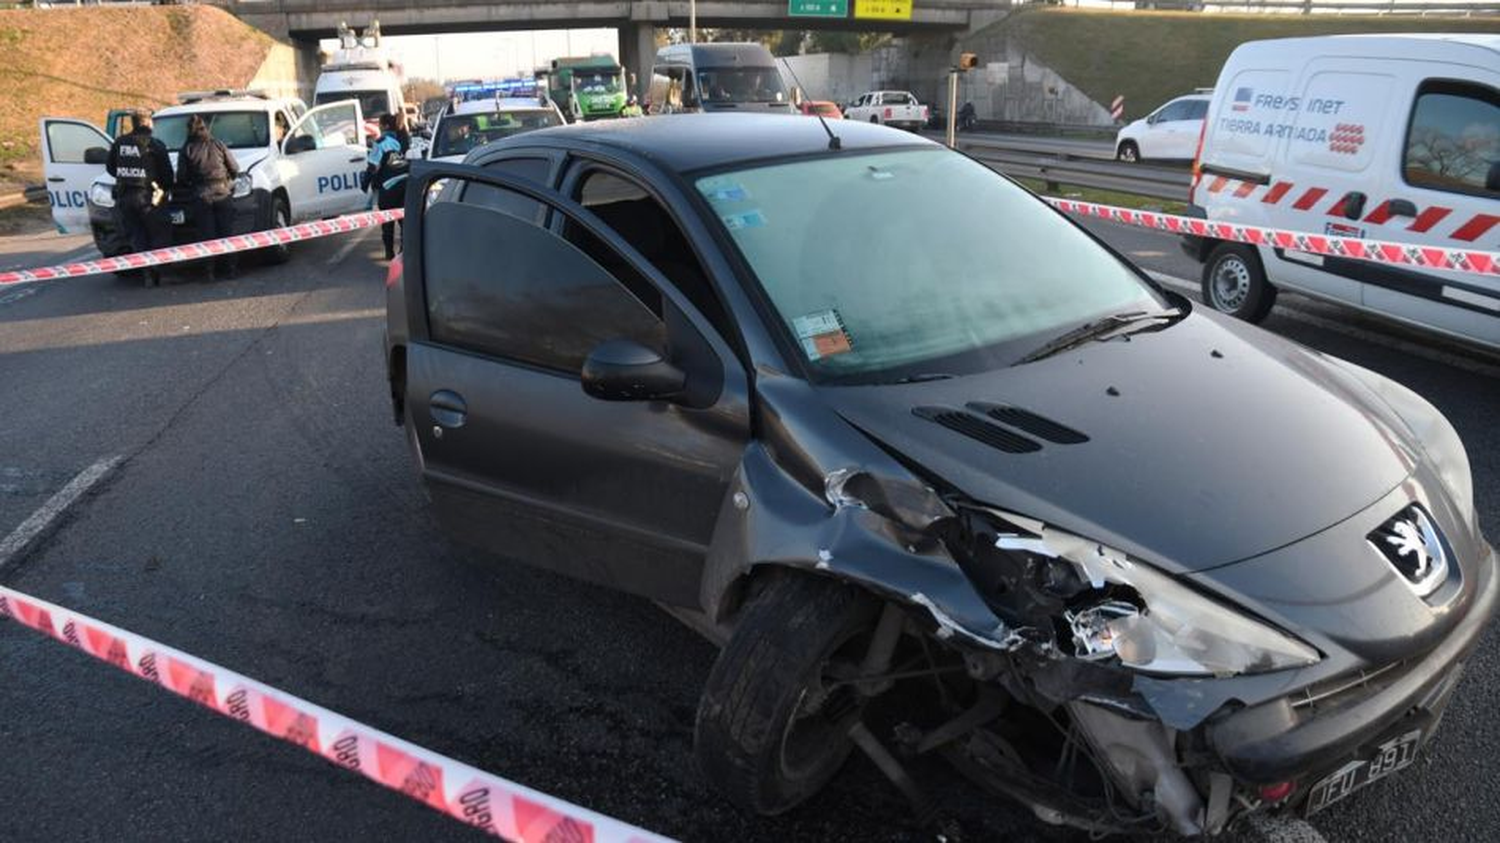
[0, 197, 1500, 287]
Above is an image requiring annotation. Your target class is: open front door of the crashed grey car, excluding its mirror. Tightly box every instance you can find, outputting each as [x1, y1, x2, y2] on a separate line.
[405, 157, 749, 608]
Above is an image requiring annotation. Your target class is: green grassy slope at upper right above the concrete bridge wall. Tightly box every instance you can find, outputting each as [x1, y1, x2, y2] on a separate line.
[984, 8, 1500, 120]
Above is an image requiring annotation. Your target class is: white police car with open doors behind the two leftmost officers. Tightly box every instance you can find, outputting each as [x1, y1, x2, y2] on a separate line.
[42, 90, 368, 261]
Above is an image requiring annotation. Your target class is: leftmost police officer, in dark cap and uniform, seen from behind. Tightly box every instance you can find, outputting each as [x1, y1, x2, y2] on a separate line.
[105, 111, 173, 287]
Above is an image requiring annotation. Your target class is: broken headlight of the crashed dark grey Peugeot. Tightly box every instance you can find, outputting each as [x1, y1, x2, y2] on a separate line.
[996, 516, 1320, 677]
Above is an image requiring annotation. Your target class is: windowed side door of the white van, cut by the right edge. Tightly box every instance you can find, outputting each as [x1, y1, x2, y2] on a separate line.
[1364, 62, 1500, 337]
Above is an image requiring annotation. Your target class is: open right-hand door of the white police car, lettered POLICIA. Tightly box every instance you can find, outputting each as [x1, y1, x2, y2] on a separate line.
[276, 99, 368, 221]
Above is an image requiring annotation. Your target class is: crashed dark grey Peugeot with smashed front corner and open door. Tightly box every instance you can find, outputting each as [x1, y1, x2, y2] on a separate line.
[386, 116, 1497, 836]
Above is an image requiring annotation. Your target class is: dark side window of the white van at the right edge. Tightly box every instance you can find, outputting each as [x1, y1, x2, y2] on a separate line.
[1403, 83, 1500, 198]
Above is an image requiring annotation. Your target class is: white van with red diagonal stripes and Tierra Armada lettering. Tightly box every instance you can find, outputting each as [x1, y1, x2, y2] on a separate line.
[1184, 35, 1500, 348]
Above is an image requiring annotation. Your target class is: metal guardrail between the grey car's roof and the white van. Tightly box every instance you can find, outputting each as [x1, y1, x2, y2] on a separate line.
[959, 138, 1193, 203]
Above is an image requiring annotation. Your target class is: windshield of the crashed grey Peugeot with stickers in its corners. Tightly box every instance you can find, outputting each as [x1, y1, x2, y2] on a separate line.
[696, 150, 1163, 383]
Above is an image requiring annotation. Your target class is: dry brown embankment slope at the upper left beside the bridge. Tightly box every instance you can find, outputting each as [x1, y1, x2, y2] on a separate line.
[0, 6, 272, 194]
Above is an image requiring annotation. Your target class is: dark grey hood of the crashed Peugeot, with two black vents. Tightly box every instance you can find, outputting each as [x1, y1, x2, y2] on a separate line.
[821, 312, 1419, 573]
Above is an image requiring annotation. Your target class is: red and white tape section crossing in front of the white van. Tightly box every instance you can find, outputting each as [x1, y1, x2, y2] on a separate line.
[1047, 197, 1500, 276]
